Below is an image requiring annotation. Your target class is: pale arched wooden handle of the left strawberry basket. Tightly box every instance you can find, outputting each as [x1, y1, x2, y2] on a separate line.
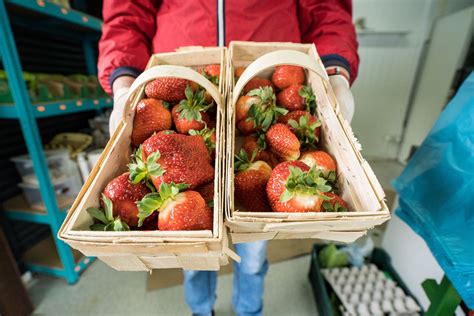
[123, 65, 223, 117]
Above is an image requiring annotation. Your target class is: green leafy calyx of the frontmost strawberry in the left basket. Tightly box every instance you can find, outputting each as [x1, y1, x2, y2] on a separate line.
[137, 182, 189, 227]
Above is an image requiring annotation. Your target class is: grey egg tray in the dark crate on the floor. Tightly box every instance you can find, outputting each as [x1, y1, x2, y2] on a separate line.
[321, 264, 421, 316]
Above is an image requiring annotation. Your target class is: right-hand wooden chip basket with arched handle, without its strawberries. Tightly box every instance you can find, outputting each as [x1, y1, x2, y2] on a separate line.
[226, 42, 390, 243]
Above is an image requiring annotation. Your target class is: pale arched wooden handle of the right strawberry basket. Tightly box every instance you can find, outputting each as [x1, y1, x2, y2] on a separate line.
[232, 50, 328, 105]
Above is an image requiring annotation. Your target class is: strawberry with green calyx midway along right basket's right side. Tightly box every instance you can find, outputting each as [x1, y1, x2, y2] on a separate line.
[278, 111, 321, 147]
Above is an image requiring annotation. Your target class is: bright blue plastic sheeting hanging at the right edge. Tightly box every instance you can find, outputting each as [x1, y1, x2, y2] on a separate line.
[393, 73, 474, 309]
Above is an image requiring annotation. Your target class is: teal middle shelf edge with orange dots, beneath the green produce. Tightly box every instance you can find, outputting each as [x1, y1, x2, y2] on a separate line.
[0, 98, 113, 119]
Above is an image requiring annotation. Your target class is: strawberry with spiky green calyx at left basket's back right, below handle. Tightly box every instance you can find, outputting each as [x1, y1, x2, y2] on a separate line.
[171, 86, 213, 134]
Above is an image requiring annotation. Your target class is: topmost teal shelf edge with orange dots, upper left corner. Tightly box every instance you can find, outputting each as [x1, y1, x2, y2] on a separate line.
[5, 0, 102, 31]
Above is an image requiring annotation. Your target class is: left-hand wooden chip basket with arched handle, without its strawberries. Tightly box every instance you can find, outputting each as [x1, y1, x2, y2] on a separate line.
[58, 48, 238, 271]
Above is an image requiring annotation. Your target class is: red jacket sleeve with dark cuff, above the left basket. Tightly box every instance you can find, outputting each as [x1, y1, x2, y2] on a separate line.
[98, 0, 159, 94]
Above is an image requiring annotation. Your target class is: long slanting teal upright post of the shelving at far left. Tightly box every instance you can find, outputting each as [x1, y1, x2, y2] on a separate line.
[0, 0, 78, 283]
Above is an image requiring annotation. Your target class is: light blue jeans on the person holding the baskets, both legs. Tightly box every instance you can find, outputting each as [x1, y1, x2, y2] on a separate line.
[184, 241, 268, 316]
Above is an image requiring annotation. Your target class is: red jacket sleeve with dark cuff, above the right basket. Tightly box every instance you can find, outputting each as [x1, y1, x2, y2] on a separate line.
[298, 0, 359, 84]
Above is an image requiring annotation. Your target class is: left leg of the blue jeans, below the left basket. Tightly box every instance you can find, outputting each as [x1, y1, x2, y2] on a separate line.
[184, 271, 217, 316]
